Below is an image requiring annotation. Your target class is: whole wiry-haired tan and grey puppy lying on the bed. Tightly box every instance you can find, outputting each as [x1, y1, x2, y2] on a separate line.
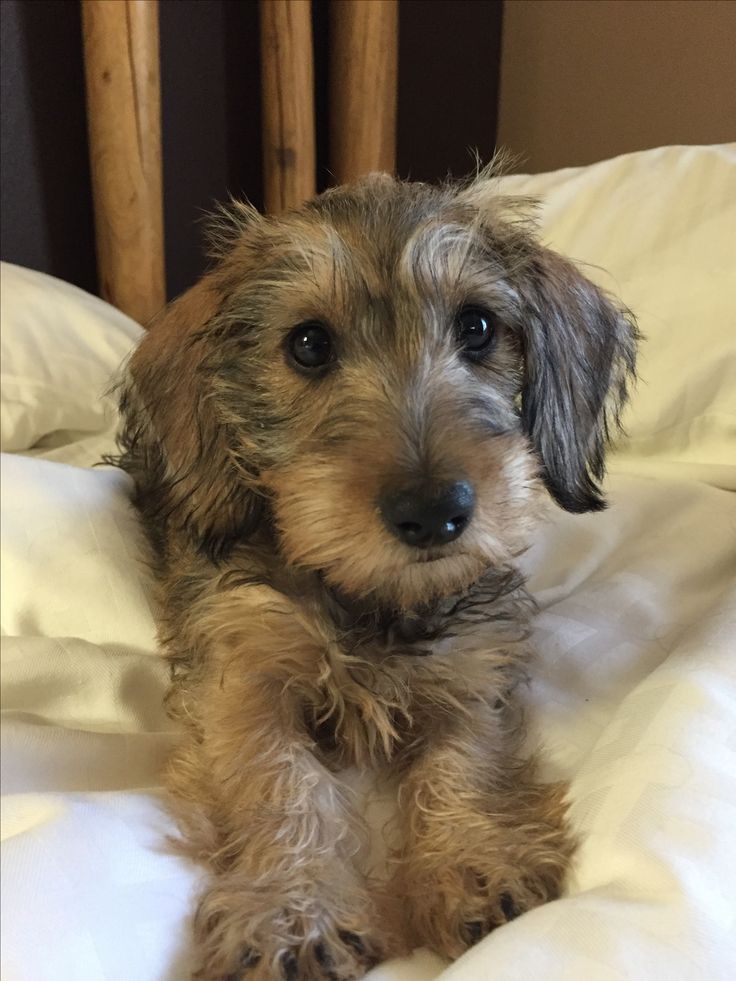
[115, 173, 636, 981]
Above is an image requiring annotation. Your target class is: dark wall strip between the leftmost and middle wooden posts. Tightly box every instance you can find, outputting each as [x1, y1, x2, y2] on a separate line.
[159, 0, 262, 297]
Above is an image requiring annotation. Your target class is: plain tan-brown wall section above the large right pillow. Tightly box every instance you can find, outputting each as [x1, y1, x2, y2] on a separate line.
[498, 0, 736, 172]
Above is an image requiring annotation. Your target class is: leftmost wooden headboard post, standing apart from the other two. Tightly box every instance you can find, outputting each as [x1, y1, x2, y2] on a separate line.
[82, 0, 166, 323]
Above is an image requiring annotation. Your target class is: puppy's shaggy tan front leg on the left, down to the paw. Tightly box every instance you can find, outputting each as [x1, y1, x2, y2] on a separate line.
[168, 613, 384, 981]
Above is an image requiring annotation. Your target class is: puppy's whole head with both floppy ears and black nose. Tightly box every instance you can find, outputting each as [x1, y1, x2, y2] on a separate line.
[123, 177, 635, 607]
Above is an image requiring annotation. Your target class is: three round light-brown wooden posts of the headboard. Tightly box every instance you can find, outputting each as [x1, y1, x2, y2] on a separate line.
[82, 0, 398, 324]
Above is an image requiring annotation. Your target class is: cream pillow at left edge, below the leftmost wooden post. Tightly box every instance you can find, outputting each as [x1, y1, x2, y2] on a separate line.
[0, 262, 142, 452]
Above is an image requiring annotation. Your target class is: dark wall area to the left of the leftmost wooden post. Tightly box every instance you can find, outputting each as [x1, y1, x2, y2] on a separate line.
[0, 0, 97, 291]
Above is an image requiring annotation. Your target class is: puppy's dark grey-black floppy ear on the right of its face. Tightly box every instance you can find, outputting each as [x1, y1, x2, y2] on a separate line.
[515, 243, 639, 512]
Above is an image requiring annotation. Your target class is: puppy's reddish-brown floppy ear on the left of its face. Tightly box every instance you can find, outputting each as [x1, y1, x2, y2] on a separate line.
[118, 271, 260, 559]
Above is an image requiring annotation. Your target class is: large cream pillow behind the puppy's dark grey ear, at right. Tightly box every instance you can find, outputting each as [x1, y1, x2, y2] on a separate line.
[499, 143, 736, 489]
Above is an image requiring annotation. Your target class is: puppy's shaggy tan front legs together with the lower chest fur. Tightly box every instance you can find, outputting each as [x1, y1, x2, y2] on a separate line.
[162, 586, 572, 978]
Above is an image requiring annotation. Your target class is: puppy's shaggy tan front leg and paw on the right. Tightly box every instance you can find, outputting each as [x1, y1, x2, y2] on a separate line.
[395, 703, 574, 958]
